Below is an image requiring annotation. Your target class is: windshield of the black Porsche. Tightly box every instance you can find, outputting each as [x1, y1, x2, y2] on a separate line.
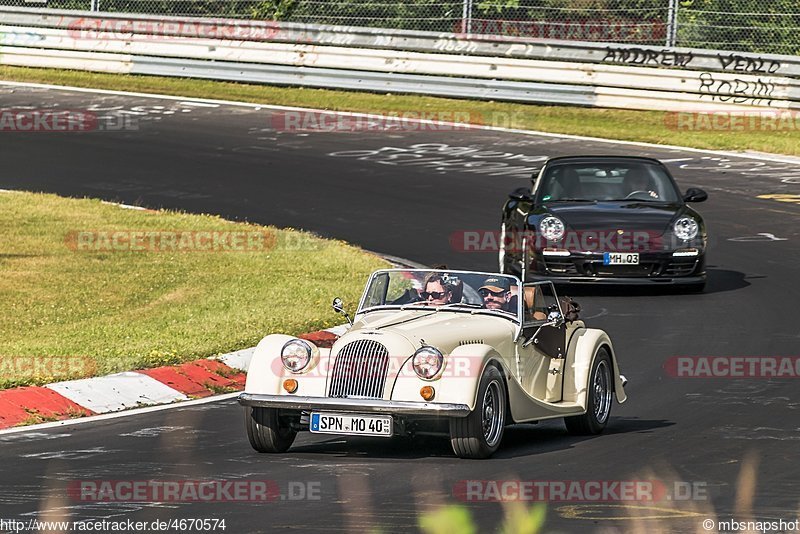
[538, 162, 680, 203]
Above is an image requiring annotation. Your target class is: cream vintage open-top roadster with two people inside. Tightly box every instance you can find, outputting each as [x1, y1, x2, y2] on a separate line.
[238, 269, 626, 458]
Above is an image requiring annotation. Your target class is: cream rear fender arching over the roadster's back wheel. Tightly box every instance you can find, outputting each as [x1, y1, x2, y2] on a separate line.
[564, 328, 627, 409]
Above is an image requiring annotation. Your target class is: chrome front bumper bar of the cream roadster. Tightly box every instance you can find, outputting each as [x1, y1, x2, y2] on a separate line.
[238, 393, 470, 417]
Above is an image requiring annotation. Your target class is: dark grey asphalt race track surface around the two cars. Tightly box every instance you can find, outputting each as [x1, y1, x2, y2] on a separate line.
[0, 81, 800, 533]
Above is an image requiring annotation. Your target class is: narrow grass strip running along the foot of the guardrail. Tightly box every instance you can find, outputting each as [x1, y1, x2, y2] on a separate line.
[0, 67, 800, 155]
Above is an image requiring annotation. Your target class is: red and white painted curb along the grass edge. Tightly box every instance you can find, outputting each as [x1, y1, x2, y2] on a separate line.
[0, 326, 345, 429]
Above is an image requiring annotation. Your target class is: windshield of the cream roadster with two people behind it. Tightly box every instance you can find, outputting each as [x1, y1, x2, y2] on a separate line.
[358, 269, 519, 317]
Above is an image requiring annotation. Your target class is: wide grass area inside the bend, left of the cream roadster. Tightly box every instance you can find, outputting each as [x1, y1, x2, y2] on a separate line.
[0, 192, 387, 388]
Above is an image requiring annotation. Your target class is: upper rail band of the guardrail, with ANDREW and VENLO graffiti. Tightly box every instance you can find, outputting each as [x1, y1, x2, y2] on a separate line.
[6, 8, 800, 77]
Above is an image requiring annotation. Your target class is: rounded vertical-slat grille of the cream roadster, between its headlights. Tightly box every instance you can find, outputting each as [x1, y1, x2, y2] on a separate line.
[328, 339, 389, 399]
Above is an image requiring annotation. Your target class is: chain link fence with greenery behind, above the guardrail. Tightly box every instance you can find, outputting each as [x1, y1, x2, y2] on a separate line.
[6, 0, 800, 55]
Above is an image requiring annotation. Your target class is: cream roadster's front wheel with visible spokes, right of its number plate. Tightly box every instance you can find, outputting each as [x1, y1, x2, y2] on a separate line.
[450, 365, 508, 459]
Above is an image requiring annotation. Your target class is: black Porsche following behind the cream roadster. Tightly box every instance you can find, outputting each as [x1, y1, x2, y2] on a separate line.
[500, 156, 708, 291]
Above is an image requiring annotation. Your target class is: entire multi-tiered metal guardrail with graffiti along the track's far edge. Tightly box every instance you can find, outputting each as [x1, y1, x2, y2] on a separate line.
[0, 8, 800, 111]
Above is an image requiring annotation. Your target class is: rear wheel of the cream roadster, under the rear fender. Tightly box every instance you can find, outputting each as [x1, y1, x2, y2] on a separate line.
[564, 348, 614, 436]
